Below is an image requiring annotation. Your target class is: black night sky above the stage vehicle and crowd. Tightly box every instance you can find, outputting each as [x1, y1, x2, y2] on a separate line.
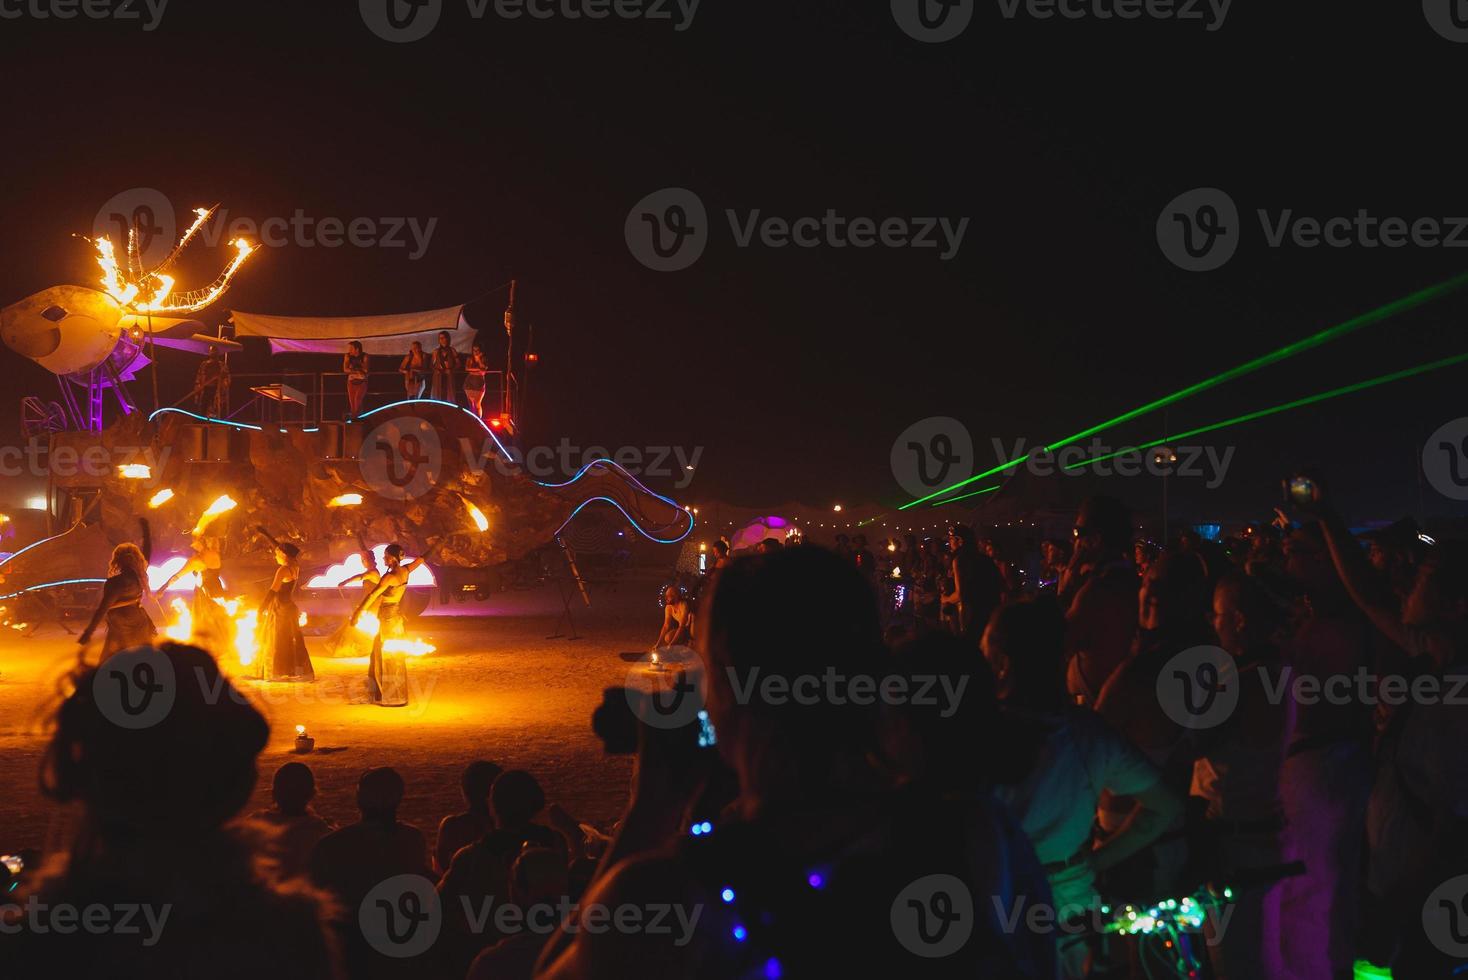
[0, 0, 1468, 528]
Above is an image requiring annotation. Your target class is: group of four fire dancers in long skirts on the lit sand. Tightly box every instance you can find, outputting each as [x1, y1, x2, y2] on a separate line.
[78, 521, 439, 707]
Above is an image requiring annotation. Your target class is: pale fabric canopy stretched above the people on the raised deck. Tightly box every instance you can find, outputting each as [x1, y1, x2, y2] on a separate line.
[229, 307, 474, 355]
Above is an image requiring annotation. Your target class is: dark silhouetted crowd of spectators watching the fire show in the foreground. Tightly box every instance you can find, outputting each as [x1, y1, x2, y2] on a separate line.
[0, 484, 1468, 980]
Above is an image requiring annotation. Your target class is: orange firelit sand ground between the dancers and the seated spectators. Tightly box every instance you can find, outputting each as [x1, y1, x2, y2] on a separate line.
[0, 571, 661, 852]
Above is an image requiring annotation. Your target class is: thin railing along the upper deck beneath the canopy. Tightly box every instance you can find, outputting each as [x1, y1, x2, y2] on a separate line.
[175, 371, 518, 425]
